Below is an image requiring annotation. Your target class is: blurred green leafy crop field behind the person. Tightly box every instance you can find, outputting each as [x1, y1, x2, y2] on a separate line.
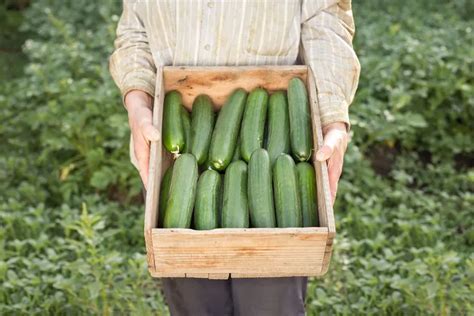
[0, 0, 474, 315]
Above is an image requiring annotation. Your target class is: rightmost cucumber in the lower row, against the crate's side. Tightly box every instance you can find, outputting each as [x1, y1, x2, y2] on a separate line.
[296, 162, 319, 227]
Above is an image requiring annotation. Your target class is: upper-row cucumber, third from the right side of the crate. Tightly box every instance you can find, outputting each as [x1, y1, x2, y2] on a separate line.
[240, 88, 268, 162]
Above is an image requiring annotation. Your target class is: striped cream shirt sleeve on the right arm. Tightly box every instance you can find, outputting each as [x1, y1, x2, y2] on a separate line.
[301, 0, 360, 128]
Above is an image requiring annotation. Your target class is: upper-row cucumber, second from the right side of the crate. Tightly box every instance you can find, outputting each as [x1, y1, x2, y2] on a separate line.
[266, 91, 290, 166]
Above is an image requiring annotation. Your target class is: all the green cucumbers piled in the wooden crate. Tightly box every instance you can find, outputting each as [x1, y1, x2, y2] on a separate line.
[158, 78, 319, 230]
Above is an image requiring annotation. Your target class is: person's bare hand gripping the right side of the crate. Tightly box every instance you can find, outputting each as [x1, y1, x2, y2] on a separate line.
[316, 122, 349, 204]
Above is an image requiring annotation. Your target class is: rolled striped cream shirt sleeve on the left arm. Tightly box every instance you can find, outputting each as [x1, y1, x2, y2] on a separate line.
[109, 0, 156, 100]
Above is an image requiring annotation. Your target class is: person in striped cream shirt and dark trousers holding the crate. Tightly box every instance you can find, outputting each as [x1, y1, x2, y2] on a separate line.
[109, 0, 360, 316]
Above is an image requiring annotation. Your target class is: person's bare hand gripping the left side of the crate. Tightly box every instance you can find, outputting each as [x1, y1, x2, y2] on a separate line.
[125, 90, 160, 189]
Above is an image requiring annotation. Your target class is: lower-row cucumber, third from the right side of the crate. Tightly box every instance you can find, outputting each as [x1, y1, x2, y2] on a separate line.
[247, 148, 276, 227]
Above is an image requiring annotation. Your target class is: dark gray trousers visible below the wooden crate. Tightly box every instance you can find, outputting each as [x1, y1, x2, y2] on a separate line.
[161, 277, 307, 316]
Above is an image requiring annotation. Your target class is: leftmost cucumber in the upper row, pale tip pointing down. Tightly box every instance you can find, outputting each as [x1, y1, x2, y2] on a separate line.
[163, 91, 185, 154]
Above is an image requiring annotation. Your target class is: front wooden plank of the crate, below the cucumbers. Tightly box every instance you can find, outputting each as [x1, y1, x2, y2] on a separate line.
[152, 227, 328, 276]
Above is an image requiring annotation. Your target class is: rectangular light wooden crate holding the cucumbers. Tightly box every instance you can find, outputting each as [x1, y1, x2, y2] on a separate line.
[145, 66, 336, 279]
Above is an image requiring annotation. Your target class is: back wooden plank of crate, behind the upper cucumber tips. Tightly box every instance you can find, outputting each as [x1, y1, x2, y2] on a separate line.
[164, 65, 307, 109]
